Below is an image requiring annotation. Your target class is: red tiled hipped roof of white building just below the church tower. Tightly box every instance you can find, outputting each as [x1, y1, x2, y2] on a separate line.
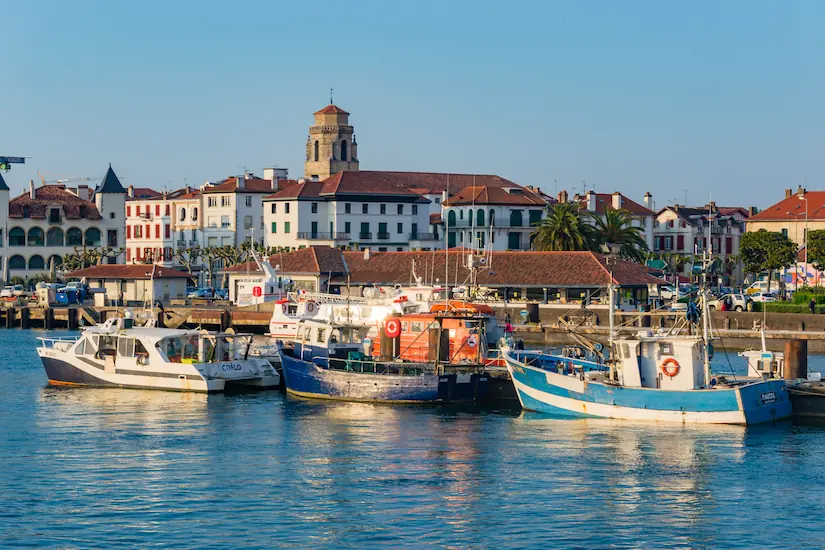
[266, 171, 428, 202]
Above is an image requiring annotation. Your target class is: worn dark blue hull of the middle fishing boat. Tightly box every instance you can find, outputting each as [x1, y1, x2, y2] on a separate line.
[281, 352, 487, 403]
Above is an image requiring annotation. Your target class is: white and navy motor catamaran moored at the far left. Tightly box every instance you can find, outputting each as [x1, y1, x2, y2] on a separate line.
[37, 318, 280, 392]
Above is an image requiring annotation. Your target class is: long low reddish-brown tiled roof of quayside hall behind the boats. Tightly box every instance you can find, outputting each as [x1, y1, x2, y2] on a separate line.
[336, 249, 663, 287]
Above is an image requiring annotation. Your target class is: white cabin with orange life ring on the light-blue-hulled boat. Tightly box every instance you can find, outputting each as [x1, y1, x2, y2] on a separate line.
[613, 332, 705, 390]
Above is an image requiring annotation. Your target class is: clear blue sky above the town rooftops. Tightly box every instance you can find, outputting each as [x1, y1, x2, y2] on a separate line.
[0, 0, 825, 207]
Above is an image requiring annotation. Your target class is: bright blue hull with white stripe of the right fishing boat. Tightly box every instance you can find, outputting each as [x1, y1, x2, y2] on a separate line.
[507, 356, 791, 424]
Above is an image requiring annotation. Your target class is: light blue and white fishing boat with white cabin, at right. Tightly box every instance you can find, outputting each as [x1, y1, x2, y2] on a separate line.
[502, 246, 791, 424]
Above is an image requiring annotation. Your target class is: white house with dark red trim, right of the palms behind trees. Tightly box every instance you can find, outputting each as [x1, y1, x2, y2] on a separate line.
[651, 202, 749, 284]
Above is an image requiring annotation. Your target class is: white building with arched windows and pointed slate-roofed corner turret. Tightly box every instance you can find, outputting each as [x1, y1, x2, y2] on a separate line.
[0, 166, 126, 279]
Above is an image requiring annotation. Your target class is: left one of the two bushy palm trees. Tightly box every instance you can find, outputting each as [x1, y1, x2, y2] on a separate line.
[533, 202, 595, 251]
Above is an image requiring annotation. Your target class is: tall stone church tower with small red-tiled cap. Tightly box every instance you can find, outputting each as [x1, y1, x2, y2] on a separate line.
[304, 102, 358, 180]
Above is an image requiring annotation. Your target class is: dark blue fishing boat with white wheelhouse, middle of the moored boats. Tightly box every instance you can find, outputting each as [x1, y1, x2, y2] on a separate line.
[278, 319, 487, 403]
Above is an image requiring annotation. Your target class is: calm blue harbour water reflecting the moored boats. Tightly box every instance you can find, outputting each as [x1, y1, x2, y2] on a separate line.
[0, 330, 825, 548]
